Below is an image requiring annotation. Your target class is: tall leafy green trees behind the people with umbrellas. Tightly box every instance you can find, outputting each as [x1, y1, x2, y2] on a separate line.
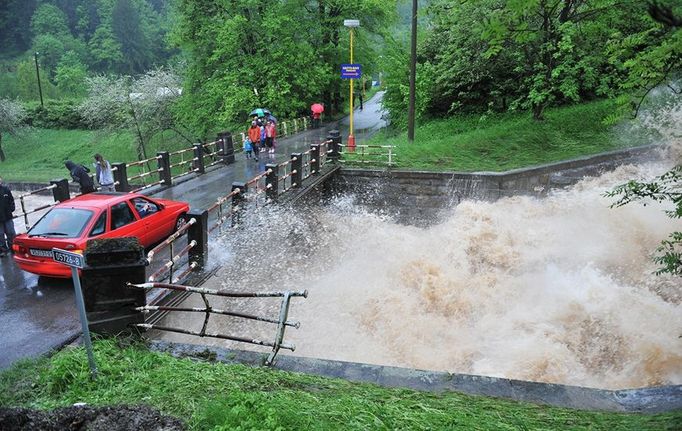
[175, 0, 395, 135]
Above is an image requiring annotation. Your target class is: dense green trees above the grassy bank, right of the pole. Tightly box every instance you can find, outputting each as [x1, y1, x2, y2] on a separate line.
[385, 0, 682, 124]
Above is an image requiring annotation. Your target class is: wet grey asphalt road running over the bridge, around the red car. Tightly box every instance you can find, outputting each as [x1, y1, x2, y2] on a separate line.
[0, 93, 384, 369]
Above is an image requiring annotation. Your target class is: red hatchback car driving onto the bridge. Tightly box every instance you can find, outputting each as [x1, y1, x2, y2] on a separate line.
[12, 192, 189, 278]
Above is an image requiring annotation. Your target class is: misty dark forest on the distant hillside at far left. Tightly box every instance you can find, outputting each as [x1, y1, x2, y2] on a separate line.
[0, 0, 175, 98]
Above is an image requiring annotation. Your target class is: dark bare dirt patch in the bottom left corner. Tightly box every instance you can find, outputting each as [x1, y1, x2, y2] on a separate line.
[0, 406, 185, 431]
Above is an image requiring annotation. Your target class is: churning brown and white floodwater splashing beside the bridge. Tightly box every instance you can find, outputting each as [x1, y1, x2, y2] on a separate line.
[164, 160, 682, 389]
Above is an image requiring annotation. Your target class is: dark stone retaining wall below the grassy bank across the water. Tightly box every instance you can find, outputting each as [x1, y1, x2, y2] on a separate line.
[332, 146, 662, 224]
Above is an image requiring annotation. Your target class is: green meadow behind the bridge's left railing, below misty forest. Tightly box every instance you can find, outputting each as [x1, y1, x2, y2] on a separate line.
[0, 129, 189, 182]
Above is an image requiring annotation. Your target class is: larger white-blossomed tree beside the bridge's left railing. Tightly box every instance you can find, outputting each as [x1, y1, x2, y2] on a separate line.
[79, 69, 192, 164]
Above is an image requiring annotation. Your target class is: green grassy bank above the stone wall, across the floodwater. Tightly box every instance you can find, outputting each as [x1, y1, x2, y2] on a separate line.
[368, 100, 652, 171]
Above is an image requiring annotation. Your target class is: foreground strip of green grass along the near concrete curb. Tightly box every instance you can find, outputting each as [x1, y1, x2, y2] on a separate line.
[0, 340, 682, 431]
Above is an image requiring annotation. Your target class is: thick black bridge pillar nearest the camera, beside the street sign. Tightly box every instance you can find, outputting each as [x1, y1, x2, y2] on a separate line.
[81, 238, 147, 335]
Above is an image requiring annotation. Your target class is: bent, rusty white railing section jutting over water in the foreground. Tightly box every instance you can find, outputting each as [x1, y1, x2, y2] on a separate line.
[128, 282, 308, 365]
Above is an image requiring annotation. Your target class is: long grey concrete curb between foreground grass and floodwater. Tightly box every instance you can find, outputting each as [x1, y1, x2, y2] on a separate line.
[149, 340, 682, 413]
